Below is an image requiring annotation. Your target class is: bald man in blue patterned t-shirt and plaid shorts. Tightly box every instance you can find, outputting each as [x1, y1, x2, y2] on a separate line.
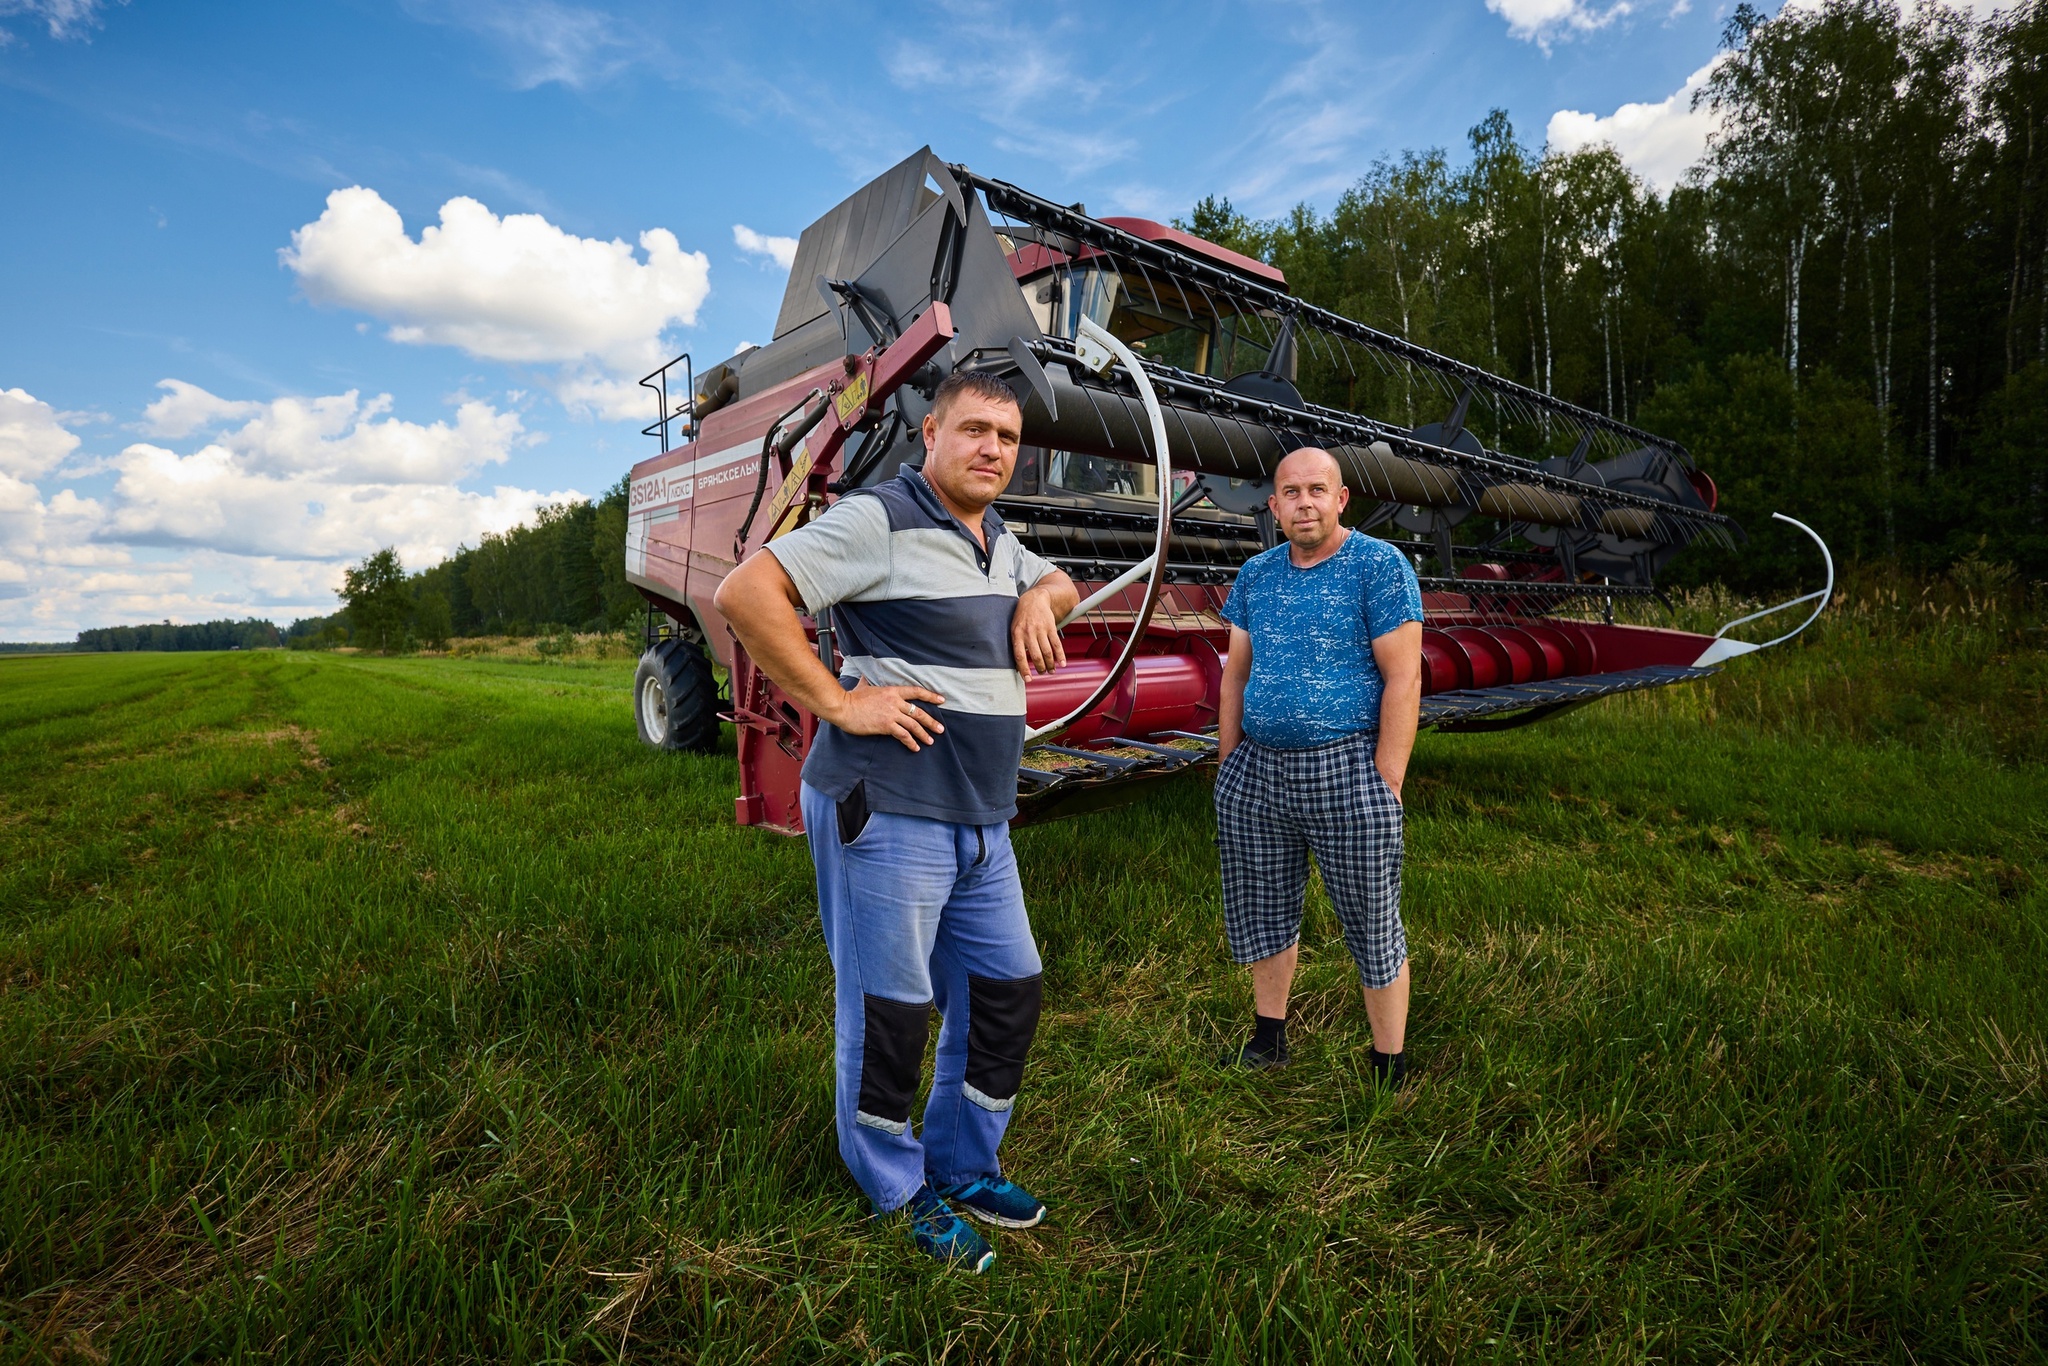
[1217, 446, 1421, 1087]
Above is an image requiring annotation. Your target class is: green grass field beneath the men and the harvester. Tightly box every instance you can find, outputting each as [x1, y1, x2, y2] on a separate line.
[0, 594, 2048, 1362]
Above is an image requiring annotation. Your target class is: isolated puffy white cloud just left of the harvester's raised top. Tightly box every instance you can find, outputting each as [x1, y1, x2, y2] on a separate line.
[279, 186, 711, 375]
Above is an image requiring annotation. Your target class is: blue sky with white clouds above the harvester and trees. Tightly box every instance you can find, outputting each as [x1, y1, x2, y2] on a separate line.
[0, 0, 1761, 639]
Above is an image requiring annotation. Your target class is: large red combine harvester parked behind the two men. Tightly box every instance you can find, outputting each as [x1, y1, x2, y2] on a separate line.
[627, 150, 1833, 834]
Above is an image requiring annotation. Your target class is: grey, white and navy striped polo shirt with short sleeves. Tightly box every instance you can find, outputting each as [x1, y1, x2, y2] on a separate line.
[768, 469, 1053, 825]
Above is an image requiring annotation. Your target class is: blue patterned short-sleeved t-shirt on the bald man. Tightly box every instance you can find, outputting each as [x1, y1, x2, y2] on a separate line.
[1223, 530, 1421, 750]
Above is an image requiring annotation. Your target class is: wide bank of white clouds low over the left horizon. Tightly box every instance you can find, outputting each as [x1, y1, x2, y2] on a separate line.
[0, 379, 580, 639]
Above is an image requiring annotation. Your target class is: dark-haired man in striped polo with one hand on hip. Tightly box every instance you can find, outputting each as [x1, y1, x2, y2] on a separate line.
[717, 373, 1079, 1272]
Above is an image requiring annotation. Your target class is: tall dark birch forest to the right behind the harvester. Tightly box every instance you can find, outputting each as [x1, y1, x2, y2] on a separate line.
[1180, 0, 2048, 588]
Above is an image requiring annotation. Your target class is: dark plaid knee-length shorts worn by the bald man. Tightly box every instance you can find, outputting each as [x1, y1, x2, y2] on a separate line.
[1217, 731, 1407, 987]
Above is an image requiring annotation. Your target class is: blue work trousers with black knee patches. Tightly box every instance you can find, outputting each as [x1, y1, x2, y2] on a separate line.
[803, 782, 1042, 1212]
